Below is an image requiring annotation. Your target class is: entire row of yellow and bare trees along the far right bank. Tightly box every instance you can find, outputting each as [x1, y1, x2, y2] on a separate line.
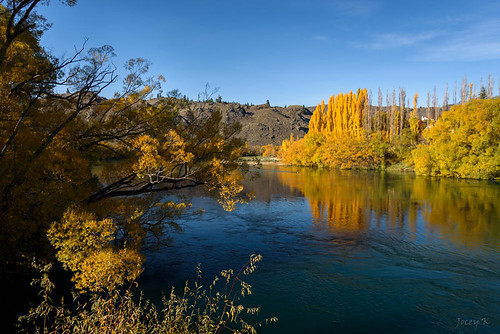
[279, 83, 500, 179]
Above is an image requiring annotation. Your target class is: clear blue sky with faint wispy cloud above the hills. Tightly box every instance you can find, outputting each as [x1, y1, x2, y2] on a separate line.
[39, 0, 500, 106]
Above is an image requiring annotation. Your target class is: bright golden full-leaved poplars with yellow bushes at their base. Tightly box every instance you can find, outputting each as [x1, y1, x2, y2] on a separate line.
[280, 89, 386, 169]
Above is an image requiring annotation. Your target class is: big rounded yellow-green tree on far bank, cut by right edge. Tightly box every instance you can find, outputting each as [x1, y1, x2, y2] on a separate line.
[413, 98, 500, 179]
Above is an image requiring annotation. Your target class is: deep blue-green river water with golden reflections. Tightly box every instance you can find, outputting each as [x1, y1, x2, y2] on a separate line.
[140, 166, 500, 333]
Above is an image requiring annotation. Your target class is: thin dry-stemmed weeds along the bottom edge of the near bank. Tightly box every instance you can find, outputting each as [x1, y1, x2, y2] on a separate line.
[20, 255, 277, 334]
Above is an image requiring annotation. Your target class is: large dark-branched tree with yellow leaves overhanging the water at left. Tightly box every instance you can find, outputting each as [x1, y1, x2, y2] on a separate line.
[0, 0, 246, 290]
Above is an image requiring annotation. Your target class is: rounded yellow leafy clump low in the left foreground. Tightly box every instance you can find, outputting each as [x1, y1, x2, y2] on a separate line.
[47, 208, 144, 291]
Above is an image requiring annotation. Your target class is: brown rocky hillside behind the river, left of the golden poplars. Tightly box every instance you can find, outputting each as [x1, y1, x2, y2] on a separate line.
[149, 99, 313, 146]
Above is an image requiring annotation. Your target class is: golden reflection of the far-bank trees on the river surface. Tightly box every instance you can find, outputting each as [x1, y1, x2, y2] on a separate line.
[277, 168, 500, 246]
